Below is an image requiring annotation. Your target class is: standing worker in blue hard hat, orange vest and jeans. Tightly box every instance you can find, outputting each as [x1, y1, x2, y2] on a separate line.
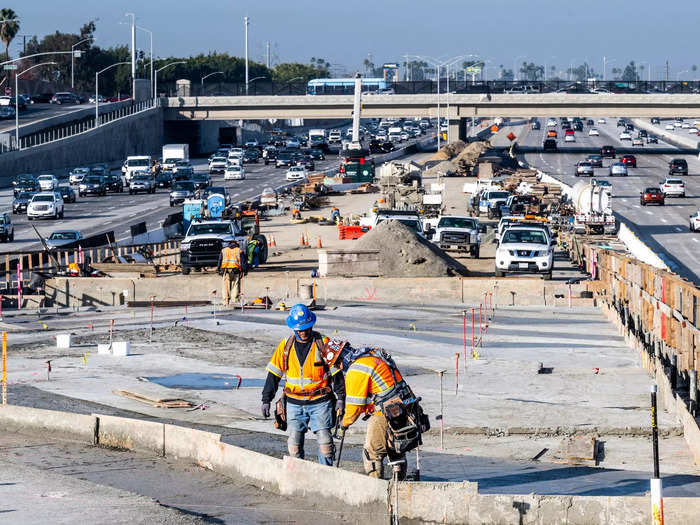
[262, 304, 345, 466]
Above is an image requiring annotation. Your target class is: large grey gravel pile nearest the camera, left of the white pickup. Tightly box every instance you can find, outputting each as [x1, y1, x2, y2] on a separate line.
[355, 220, 468, 277]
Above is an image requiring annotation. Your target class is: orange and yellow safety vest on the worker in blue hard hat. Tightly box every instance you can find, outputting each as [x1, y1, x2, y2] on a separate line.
[267, 332, 340, 401]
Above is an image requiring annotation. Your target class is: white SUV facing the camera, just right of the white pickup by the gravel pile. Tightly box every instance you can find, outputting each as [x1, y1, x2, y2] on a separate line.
[496, 227, 554, 280]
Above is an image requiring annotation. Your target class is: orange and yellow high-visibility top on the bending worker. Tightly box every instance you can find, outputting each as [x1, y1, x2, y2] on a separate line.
[345, 354, 403, 421]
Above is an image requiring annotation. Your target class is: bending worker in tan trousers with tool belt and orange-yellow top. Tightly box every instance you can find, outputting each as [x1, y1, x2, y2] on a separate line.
[340, 348, 430, 480]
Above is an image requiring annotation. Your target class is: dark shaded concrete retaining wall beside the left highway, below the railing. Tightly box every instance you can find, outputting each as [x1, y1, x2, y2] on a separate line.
[0, 108, 163, 186]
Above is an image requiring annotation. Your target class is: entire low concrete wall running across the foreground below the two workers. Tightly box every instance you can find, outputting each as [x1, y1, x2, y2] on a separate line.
[0, 406, 700, 525]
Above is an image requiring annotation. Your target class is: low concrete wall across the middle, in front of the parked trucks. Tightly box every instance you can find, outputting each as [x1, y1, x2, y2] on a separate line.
[45, 272, 592, 306]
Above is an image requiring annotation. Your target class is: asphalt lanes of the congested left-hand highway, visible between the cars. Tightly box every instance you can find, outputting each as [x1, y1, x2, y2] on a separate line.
[0, 135, 426, 253]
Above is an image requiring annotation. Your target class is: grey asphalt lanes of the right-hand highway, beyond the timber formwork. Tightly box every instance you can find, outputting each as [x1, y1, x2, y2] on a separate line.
[523, 118, 700, 283]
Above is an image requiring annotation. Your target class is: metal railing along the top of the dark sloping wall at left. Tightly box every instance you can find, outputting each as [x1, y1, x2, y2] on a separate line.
[0, 100, 156, 153]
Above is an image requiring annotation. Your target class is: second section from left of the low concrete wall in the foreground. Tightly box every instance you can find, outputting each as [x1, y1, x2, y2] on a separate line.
[93, 414, 165, 456]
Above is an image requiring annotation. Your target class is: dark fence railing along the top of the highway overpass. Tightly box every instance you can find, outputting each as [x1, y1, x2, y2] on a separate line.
[159, 79, 700, 97]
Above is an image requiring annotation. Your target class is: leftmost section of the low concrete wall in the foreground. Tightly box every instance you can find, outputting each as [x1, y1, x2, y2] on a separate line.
[0, 405, 97, 444]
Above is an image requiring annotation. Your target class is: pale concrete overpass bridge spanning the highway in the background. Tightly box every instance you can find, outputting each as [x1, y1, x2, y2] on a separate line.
[161, 93, 700, 138]
